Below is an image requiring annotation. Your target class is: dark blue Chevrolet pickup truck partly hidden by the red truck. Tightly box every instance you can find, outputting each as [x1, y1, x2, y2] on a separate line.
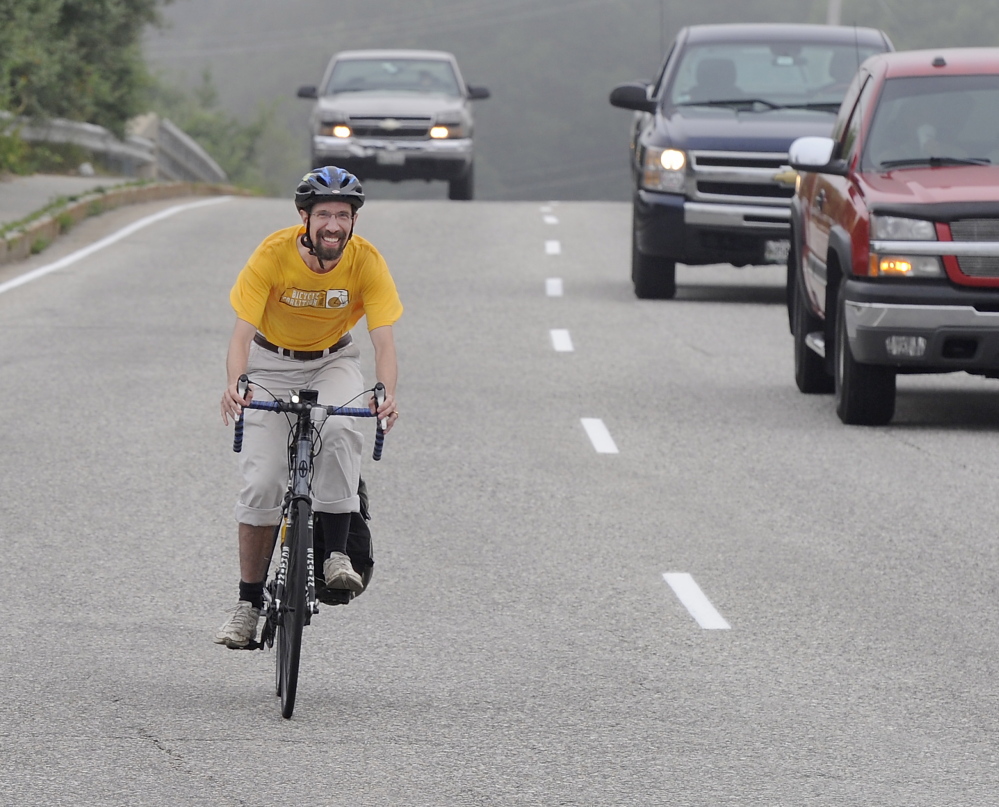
[610, 24, 893, 299]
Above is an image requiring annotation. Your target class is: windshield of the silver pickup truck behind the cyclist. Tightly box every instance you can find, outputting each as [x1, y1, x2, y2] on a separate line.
[326, 59, 461, 97]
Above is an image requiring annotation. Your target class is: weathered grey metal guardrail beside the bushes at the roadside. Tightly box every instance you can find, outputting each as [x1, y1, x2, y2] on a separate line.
[0, 112, 228, 182]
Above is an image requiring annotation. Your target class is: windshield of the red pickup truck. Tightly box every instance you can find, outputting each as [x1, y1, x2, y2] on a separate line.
[861, 76, 999, 171]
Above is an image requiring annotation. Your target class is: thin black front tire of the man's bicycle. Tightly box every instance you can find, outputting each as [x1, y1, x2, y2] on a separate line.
[276, 501, 312, 719]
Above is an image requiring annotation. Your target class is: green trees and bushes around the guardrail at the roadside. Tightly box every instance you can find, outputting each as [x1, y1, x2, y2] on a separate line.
[0, 0, 282, 192]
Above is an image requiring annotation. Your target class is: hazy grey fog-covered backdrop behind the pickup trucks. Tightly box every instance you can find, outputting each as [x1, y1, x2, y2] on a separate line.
[145, 0, 997, 200]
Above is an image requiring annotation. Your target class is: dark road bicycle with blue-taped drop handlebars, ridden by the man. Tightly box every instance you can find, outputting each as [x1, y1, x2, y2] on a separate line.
[232, 374, 386, 719]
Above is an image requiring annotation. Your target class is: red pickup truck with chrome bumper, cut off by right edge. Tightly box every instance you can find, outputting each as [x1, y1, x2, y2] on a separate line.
[787, 48, 999, 425]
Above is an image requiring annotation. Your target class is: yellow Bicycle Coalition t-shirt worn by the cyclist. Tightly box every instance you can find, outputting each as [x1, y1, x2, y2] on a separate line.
[229, 226, 402, 350]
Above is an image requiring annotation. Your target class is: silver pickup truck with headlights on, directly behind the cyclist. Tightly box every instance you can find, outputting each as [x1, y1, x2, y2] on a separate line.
[298, 50, 489, 200]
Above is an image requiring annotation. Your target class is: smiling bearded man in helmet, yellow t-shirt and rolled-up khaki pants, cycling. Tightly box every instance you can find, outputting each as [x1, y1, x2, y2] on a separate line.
[215, 166, 402, 648]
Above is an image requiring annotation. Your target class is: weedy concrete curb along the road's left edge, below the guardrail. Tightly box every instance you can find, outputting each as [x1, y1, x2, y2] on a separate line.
[0, 182, 253, 266]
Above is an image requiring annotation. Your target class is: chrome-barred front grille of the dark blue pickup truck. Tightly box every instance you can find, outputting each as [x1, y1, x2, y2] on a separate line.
[690, 151, 794, 207]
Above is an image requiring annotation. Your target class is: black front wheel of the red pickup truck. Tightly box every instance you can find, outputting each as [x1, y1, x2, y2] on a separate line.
[835, 296, 895, 426]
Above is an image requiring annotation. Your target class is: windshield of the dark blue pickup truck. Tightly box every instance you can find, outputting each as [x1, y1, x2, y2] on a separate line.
[666, 42, 880, 112]
